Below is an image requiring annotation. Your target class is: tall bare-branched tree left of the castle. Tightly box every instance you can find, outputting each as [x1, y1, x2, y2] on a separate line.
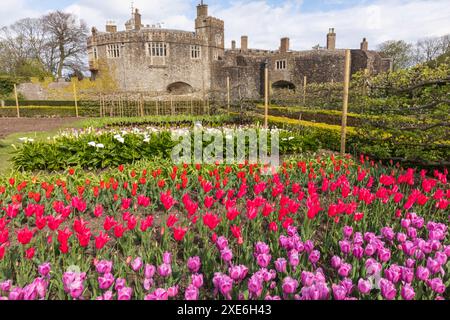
[42, 11, 88, 78]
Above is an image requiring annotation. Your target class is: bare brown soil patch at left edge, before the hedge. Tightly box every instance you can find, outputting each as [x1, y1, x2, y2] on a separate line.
[0, 118, 79, 139]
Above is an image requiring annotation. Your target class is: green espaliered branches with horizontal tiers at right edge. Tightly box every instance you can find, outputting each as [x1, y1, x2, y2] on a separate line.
[358, 63, 450, 165]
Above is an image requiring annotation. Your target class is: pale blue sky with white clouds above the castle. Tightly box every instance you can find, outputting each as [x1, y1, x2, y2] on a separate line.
[0, 0, 450, 50]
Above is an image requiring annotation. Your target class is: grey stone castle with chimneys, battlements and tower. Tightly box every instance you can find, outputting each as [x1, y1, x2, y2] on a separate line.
[88, 1, 391, 99]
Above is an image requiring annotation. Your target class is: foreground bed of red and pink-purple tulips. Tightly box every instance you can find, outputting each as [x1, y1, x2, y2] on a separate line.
[0, 156, 450, 300]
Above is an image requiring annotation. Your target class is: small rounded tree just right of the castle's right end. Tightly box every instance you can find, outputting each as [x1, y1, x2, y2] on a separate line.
[378, 40, 414, 71]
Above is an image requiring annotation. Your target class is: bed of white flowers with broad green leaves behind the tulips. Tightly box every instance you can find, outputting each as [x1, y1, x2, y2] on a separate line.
[12, 126, 319, 171]
